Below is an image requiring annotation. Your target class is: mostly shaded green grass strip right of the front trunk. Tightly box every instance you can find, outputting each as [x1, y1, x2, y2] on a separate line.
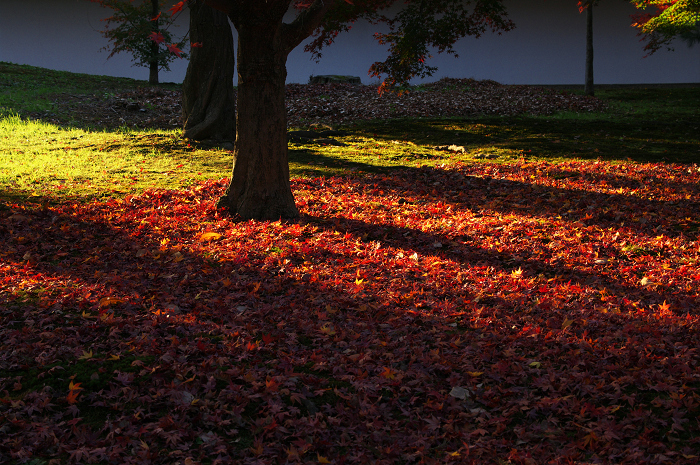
[291, 87, 700, 176]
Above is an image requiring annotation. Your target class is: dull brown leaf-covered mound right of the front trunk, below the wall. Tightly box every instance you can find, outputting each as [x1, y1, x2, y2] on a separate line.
[286, 78, 607, 126]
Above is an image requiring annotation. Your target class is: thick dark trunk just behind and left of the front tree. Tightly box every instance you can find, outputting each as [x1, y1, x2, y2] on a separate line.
[182, 1, 236, 140]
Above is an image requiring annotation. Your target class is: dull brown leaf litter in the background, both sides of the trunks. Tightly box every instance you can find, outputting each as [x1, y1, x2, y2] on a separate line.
[39, 78, 606, 129]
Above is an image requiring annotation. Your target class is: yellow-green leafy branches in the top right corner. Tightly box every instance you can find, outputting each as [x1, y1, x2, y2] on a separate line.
[631, 0, 700, 54]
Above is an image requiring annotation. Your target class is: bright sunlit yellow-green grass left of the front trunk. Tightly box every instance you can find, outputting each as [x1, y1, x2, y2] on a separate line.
[0, 116, 231, 201]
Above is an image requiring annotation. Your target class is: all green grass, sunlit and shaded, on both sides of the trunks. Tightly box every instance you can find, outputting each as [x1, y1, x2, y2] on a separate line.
[0, 63, 700, 205]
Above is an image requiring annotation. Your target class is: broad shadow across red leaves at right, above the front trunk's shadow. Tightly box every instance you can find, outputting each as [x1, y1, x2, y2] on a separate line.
[314, 165, 700, 240]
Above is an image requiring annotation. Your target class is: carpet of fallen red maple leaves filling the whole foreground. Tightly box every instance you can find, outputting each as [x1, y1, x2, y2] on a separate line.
[0, 158, 700, 464]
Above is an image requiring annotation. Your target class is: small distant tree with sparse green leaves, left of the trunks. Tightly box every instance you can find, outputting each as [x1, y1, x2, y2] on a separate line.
[89, 0, 187, 84]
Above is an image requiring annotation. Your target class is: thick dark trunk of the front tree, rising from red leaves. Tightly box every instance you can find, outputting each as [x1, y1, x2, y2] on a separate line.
[218, 9, 299, 220]
